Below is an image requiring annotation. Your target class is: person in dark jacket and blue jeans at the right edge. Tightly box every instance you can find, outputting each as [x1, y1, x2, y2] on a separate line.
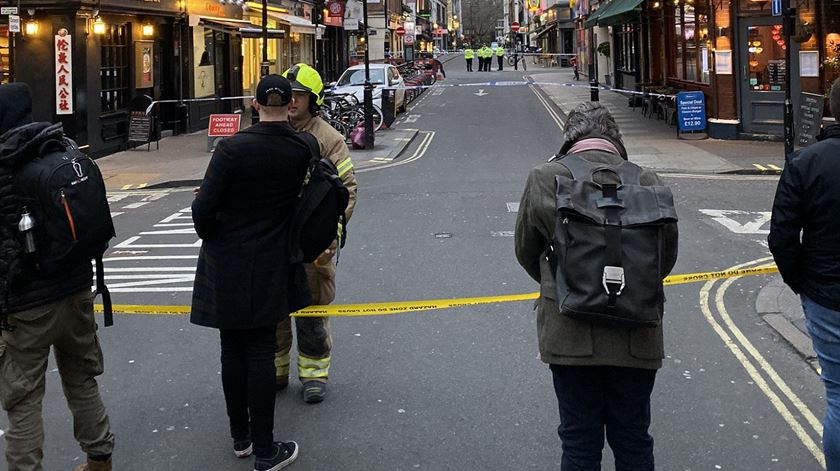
[767, 79, 840, 471]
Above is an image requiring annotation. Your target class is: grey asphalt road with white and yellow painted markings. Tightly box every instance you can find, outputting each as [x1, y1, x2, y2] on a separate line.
[0, 61, 823, 471]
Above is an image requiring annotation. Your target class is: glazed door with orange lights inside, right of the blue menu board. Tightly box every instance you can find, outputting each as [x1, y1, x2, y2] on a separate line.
[738, 17, 799, 136]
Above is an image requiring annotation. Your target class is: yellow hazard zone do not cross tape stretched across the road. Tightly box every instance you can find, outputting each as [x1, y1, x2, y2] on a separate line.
[96, 265, 779, 317]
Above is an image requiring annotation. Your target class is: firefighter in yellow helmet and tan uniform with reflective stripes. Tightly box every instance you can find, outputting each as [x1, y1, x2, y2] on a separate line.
[274, 64, 357, 403]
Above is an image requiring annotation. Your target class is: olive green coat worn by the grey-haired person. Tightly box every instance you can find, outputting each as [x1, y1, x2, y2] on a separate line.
[515, 151, 677, 369]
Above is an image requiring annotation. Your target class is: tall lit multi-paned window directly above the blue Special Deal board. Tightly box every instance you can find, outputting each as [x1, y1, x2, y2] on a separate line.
[673, 2, 712, 83]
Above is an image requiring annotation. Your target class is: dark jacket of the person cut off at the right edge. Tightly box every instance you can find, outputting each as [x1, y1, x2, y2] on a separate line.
[767, 124, 840, 310]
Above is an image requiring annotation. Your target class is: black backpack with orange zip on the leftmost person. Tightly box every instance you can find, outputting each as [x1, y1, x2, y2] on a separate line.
[14, 138, 116, 326]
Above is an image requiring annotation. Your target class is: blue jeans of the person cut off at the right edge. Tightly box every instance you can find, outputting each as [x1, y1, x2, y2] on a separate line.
[802, 294, 840, 471]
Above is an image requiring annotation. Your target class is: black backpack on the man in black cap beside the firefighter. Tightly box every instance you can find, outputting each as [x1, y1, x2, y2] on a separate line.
[289, 133, 350, 264]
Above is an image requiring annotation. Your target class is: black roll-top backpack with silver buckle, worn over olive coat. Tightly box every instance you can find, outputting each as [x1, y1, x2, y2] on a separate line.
[548, 154, 677, 327]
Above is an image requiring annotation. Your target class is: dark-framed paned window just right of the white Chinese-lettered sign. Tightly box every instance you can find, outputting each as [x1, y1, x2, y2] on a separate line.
[99, 24, 131, 113]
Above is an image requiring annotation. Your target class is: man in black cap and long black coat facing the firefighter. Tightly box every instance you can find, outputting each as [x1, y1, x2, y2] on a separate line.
[190, 75, 310, 471]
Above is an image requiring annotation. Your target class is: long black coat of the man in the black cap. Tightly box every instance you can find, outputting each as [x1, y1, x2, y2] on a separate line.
[190, 122, 310, 329]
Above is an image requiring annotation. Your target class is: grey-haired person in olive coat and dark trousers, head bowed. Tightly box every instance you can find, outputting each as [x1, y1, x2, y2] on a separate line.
[508, 102, 677, 471]
